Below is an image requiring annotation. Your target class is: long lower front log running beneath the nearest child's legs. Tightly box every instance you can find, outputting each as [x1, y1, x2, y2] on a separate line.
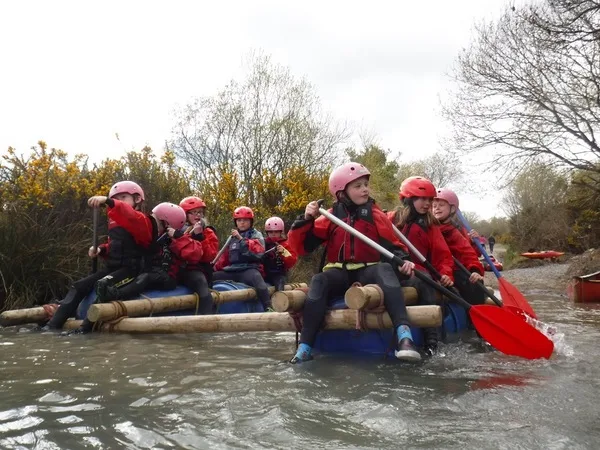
[65, 305, 442, 334]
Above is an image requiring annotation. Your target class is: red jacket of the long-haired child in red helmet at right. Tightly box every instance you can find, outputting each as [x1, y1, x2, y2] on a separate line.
[387, 211, 454, 281]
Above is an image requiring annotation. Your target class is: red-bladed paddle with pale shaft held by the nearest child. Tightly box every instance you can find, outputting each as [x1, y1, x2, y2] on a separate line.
[319, 208, 554, 359]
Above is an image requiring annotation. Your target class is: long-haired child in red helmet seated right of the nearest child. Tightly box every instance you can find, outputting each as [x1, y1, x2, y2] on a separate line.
[388, 177, 454, 355]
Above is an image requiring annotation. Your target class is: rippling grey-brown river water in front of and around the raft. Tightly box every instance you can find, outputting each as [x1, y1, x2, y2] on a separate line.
[0, 291, 600, 449]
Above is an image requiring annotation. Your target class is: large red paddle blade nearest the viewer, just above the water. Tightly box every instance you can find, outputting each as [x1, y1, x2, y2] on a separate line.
[469, 305, 554, 359]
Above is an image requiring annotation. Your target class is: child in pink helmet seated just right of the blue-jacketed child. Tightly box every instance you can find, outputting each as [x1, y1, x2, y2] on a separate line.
[263, 217, 298, 291]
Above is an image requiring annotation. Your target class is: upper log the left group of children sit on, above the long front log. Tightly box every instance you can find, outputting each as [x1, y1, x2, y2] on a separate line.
[87, 283, 307, 322]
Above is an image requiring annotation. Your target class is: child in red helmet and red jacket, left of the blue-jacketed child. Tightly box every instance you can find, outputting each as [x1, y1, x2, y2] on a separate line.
[167, 197, 219, 314]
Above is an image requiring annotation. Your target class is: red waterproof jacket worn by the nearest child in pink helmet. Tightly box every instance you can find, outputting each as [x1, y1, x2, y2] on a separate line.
[289, 199, 408, 263]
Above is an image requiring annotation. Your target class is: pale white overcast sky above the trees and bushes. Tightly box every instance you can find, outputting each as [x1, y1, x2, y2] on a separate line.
[0, 0, 507, 218]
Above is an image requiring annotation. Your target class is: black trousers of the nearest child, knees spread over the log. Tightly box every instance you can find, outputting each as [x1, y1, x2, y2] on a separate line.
[300, 263, 409, 346]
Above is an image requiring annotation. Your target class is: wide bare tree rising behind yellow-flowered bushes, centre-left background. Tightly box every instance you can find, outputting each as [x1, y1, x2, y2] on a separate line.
[169, 51, 348, 203]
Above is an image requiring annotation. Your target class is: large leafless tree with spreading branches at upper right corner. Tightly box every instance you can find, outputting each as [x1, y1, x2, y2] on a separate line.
[444, 0, 600, 191]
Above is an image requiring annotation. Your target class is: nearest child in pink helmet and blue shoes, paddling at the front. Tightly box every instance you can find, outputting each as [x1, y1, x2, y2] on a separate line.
[289, 162, 421, 364]
